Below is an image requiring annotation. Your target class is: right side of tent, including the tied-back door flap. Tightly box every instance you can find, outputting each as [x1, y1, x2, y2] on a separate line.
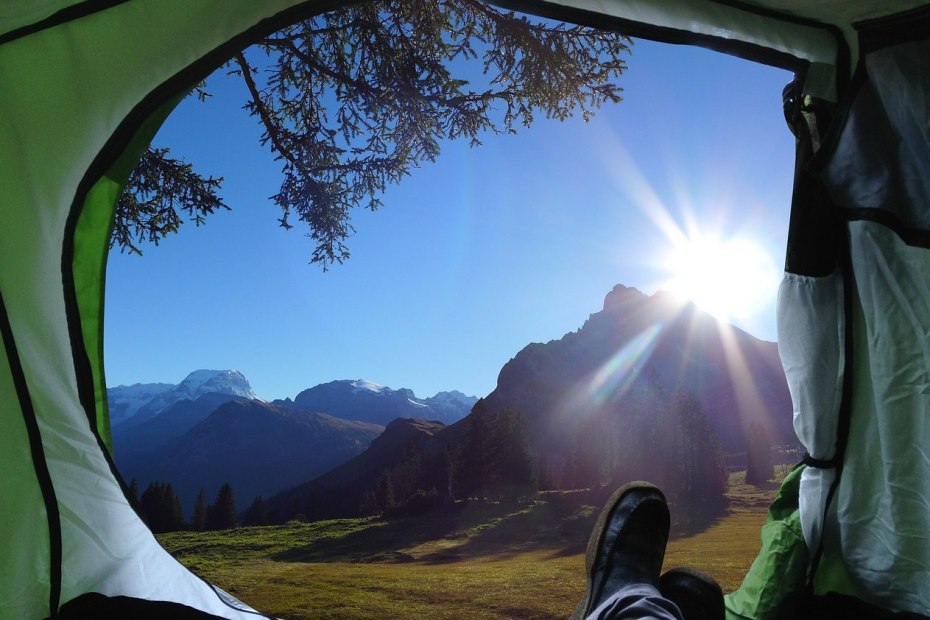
[728, 3, 930, 618]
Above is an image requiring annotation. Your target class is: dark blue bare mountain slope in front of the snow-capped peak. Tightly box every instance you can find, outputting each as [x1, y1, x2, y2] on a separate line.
[119, 400, 384, 512]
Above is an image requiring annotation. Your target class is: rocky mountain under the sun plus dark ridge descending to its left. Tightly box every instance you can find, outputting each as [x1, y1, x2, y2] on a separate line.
[268, 286, 795, 519]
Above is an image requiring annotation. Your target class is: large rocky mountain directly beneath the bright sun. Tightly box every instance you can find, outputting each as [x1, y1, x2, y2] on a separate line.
[485, 285, 795, 480]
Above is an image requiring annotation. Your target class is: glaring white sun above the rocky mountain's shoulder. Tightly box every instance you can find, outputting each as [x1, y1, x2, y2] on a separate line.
[660, 233, 779, 321]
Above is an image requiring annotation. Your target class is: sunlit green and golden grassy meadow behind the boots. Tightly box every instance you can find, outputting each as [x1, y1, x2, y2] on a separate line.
[160, 474, 775, 620]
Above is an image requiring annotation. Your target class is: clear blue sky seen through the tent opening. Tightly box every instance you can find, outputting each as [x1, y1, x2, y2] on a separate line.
[105, 36, 793, 400]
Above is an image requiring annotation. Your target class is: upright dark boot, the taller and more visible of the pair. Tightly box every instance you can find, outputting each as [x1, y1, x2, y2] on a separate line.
[572, 482, 669, 620]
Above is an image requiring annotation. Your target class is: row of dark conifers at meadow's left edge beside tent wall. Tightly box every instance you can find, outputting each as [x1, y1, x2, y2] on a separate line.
[129, 479, 270, 534]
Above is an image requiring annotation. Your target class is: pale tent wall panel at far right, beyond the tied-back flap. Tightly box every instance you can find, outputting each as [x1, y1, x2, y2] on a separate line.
[801, 18, 930, 614]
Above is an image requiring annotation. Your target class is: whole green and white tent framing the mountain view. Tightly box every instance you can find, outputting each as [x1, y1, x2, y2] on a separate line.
[0, 0, 930, 619]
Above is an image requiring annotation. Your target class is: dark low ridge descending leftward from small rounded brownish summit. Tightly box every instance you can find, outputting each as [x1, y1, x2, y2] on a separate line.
[266, 418, 447, 521]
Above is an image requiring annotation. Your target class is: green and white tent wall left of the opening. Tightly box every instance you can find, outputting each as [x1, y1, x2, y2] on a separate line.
[0, 0, 352, 618]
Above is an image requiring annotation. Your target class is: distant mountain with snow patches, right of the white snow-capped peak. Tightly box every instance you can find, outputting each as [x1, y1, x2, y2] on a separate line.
[275, 380, 478, 425]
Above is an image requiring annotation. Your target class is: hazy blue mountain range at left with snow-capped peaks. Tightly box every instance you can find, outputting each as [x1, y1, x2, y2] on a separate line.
[107, 370, 477, 514]
